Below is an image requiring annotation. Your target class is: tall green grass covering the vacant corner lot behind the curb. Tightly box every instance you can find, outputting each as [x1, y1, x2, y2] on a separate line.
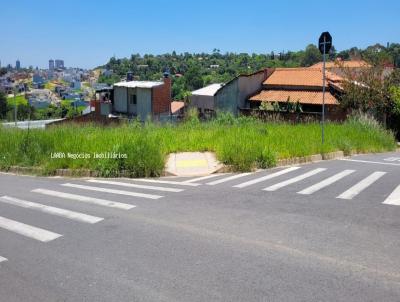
[0, 116, 396, 177]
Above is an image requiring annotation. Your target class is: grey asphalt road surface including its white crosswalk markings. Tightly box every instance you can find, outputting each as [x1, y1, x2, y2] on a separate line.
[0, 153, 400, 302]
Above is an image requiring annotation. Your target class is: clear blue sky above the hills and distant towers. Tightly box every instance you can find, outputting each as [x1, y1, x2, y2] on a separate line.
[0, 0, 400, 68]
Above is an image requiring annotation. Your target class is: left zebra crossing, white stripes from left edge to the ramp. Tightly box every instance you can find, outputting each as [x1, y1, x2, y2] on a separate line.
[0, 179, 190, 262]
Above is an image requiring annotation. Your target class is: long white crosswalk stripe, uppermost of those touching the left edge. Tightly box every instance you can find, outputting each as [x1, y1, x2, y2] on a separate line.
[0, 196, 104, 224]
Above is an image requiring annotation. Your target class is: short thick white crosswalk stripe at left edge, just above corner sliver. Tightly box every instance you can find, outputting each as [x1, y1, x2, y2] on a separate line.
[0, 216, 62, 242]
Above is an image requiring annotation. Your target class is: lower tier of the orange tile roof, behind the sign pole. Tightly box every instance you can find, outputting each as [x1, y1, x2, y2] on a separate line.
[249, 90, 339, 105]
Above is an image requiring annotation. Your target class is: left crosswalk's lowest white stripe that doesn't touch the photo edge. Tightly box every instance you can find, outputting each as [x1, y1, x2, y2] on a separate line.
[32, 189, 136, 210]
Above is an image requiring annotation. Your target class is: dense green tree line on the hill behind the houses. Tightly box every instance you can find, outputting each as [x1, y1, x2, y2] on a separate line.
[99, 43, 400, 99]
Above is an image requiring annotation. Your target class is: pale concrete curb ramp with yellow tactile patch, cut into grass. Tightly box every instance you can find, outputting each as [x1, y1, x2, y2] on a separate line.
[165, 152, 222, 176]
